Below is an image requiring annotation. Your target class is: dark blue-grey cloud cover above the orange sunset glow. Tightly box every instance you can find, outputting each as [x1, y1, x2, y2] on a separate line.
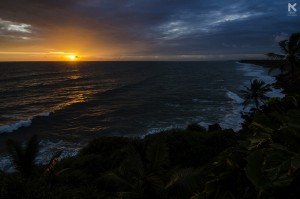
[0, 0, 300, 59]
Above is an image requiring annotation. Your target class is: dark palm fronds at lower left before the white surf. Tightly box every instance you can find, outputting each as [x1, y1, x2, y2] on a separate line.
[6, 135, 39, 178]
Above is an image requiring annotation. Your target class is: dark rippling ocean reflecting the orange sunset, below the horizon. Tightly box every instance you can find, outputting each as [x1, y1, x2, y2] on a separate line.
[0, 61, 282, 170]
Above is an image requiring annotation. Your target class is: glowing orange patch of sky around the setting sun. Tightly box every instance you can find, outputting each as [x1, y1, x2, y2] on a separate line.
[0, 25, 129, 61]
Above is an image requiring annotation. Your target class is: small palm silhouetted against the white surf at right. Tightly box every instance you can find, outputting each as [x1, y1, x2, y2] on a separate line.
[241, 79, 272, 110]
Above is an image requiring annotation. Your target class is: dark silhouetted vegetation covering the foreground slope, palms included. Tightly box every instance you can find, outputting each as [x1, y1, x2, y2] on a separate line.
[0, 33, 300, 199]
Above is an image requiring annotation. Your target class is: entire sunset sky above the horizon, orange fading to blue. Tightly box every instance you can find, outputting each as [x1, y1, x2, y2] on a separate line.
[0, 0, 300, 61]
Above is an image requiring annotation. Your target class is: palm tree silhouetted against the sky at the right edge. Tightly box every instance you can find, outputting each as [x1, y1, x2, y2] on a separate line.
[266, 32, 300, 76]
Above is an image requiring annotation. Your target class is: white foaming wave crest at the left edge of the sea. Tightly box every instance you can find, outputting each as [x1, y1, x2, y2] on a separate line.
[0, 112, 50, 134]
